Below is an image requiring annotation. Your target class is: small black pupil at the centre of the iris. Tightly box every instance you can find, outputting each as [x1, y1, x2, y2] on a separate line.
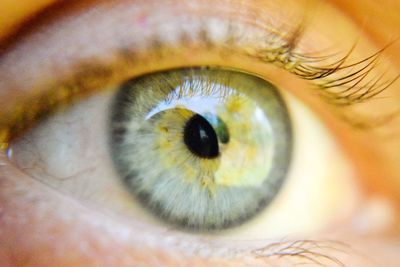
[183, 114, 219, 159]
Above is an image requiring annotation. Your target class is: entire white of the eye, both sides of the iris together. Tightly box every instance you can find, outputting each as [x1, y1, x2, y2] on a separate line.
[13, 87, 359, 239]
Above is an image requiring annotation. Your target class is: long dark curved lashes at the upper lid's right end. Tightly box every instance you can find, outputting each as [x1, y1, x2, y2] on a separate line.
[248, 24, 400, 106]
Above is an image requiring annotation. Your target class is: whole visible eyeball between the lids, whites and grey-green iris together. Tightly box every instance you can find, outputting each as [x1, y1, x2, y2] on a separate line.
[9, 68, 360, 240]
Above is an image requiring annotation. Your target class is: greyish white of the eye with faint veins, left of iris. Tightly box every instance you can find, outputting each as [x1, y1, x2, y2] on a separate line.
[11, 92, 159, 225]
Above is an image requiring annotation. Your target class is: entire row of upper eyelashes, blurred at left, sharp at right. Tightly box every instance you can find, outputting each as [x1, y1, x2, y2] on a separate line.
[0, 20, 399, 149]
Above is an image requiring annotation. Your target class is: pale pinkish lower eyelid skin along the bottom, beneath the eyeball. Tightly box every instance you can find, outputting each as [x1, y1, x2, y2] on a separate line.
[0, 158, 398, 266]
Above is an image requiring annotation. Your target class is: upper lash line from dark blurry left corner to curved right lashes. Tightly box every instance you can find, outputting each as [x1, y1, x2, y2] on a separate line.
[0, 3, 398, 149]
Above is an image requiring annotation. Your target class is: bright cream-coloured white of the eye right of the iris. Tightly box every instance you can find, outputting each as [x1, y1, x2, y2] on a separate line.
[220, 94, 361, 239]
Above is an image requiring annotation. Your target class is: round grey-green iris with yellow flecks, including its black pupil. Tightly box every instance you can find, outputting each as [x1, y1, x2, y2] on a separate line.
[110, 68, 292, 230]
